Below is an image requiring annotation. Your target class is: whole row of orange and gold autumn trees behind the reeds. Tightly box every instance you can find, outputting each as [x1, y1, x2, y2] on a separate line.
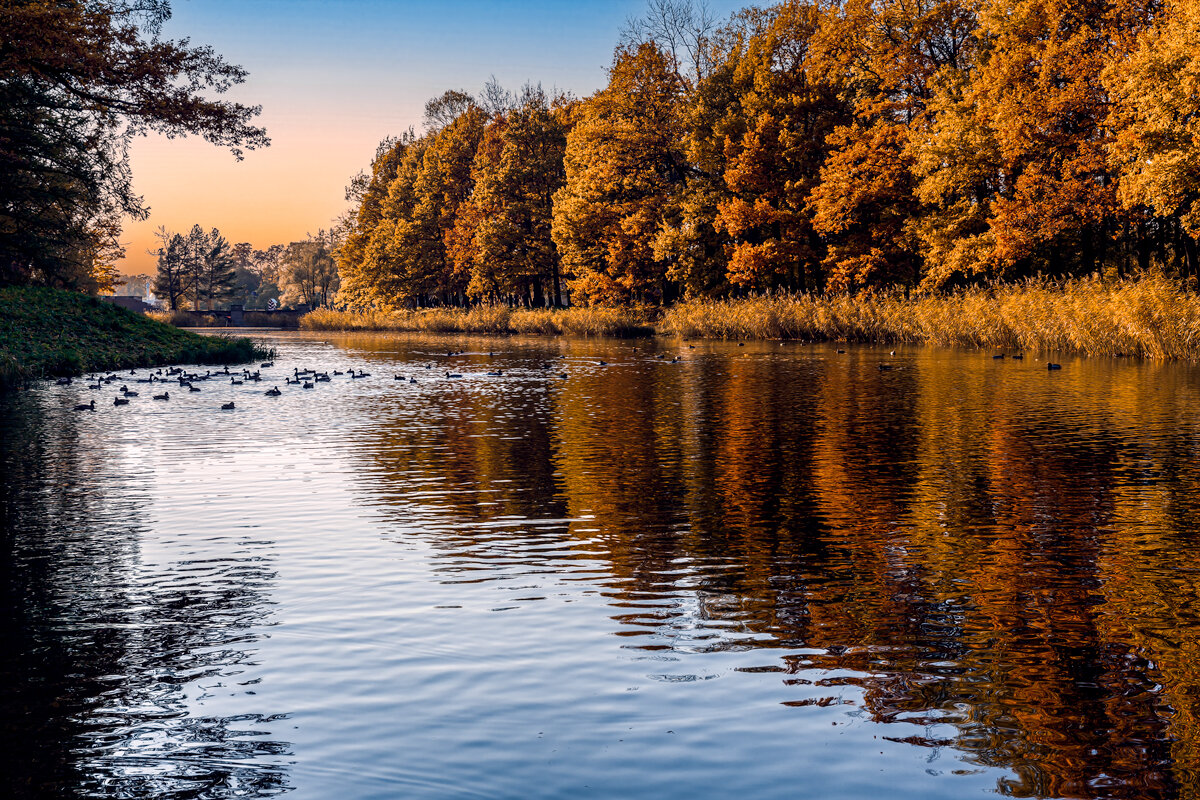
[337, 0, 1200, 308]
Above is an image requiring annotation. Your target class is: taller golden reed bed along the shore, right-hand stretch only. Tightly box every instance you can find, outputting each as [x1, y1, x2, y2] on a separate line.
[660, 273, 1200, 359]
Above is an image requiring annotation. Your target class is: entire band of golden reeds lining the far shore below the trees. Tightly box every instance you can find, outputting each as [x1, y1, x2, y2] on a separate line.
[288, 273, 1200, 361]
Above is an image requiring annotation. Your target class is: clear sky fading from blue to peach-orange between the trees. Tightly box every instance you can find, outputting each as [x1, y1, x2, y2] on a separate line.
[120, 0, 745, 275]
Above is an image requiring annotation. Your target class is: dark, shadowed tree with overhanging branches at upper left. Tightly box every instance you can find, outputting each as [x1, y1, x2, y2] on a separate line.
[0, 0, 268, 290]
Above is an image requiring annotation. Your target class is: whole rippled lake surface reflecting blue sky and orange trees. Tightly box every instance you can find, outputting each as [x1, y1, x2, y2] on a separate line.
[0, 335, 1200, 800]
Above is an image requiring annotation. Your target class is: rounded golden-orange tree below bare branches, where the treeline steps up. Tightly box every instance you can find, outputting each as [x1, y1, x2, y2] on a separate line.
[552, 42, 688, 303]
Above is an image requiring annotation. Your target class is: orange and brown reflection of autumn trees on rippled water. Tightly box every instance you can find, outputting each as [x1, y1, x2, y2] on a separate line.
[350, 344, 1200, 798]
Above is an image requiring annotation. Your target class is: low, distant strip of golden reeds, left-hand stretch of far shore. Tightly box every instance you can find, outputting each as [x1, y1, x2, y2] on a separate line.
[300, 306, 654, 336]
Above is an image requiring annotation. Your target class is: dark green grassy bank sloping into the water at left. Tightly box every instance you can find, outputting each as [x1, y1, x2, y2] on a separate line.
[0, 287, 268, 386]
